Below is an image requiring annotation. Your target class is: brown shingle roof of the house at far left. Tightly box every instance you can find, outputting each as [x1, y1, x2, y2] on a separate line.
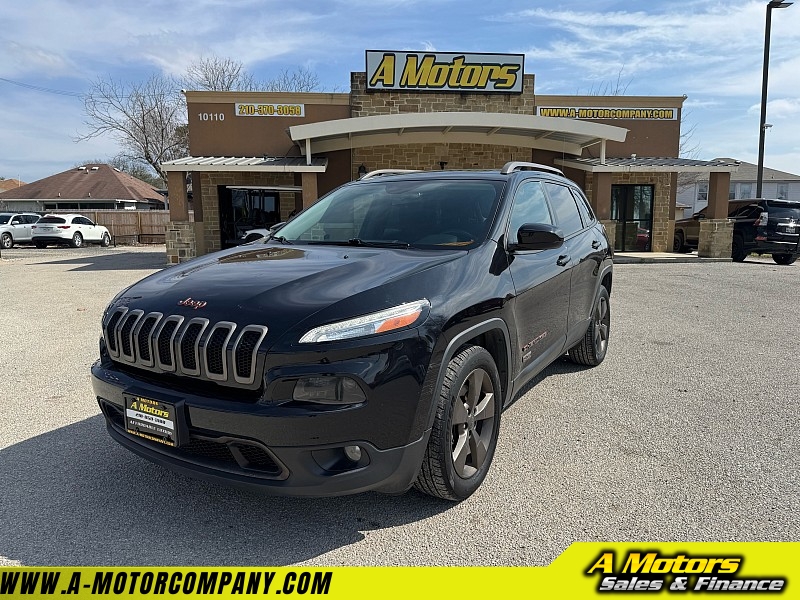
[0, 164, 164, 202]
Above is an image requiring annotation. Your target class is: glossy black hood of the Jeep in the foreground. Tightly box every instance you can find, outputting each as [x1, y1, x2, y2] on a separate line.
[117, 244, 466, 339]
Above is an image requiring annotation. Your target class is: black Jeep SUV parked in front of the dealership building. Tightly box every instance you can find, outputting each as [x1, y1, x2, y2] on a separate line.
[92, 163, 612, 500]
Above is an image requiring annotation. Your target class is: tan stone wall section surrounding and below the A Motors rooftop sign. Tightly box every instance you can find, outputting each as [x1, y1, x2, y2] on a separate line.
[350, 72, 536, 117]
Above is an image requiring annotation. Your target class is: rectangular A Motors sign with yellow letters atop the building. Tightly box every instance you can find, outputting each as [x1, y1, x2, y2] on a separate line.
[367, 50, 525, 94]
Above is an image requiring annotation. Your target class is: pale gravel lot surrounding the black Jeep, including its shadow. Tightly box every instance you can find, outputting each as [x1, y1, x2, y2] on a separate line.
[0, 246, 800, 565]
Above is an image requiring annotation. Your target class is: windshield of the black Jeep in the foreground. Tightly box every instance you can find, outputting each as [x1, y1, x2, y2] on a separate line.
[277, 179, 504, 249]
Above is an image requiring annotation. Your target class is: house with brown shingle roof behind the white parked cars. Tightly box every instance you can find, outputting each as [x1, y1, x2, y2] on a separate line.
[0, 164, 165, 212]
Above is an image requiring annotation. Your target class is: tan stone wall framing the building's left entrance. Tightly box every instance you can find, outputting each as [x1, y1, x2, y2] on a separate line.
[195, 172, 295, 254]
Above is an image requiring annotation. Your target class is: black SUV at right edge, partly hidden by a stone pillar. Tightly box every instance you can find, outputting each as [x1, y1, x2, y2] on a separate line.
[673, 199, 800, 265]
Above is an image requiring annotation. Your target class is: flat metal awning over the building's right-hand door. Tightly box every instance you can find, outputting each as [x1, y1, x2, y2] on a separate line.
[555, 156, 739, 173]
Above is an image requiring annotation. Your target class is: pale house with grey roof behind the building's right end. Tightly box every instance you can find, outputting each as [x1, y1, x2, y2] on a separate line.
[677, 158, 800, 218]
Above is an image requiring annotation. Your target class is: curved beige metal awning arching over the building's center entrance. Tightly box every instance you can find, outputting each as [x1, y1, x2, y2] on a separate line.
[289, 112, 628, 161]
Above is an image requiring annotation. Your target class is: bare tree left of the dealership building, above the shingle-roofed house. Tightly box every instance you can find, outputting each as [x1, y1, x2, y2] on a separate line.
[77, 75, 188, 180]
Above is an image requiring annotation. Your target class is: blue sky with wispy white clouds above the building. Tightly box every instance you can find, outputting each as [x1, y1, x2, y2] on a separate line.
[0, 0, 800, 182]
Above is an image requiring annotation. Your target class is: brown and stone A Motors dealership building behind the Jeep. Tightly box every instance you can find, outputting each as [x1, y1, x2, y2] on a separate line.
[162, 51, 737, 263]
